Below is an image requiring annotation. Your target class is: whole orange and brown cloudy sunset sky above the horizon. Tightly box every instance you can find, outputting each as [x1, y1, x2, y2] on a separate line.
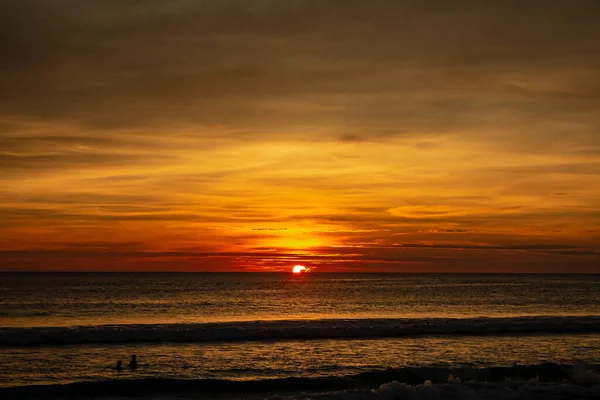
[0, 0, 600, 273]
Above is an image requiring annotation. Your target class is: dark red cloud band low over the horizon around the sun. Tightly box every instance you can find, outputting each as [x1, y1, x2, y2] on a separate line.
[0, 243, 599, 272]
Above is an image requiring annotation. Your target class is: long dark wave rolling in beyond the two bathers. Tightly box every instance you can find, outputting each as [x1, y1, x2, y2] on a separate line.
[0, 316, 600, 346]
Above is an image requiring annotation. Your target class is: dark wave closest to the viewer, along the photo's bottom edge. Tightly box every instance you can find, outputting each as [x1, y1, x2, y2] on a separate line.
[0, 363, 600, 400]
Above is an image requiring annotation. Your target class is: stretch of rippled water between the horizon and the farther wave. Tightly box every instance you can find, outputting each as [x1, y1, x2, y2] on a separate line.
[0, 273, 600, 327]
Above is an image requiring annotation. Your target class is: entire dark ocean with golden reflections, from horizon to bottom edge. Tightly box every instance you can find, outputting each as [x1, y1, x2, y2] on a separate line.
[0, 273, 600, 399]
